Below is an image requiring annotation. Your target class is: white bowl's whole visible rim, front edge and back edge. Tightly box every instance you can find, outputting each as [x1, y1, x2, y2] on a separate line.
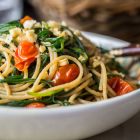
[0, 32, 140, 115]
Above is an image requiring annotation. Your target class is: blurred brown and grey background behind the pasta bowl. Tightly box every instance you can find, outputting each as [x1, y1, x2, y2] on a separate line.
[0, 0, 140, 43]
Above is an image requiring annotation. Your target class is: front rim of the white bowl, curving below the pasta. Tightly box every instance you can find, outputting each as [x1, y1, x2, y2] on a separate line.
[0, 89, 140, 114]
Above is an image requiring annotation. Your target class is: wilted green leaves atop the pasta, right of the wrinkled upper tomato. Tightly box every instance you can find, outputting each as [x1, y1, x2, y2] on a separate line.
[36, 26, 88, 63]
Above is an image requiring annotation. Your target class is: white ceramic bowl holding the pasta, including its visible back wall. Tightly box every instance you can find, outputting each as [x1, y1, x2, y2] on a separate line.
[0, 33, 140, 140]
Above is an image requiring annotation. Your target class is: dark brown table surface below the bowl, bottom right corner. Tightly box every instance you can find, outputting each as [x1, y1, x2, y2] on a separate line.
[85, 112, 140, 140]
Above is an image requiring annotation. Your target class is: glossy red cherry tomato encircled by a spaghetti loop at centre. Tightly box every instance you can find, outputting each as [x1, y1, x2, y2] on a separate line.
[53, 64, 80, 86]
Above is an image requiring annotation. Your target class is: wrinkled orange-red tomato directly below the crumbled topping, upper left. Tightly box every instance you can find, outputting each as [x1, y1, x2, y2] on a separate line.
[14, 41, 38, 71]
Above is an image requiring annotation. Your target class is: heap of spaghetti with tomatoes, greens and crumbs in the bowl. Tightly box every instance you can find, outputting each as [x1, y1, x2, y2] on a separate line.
[0, 17, 134, 107]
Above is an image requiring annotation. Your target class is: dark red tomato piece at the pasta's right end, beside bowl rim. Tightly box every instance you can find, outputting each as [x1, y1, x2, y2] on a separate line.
[108, 77, 134, 96]
